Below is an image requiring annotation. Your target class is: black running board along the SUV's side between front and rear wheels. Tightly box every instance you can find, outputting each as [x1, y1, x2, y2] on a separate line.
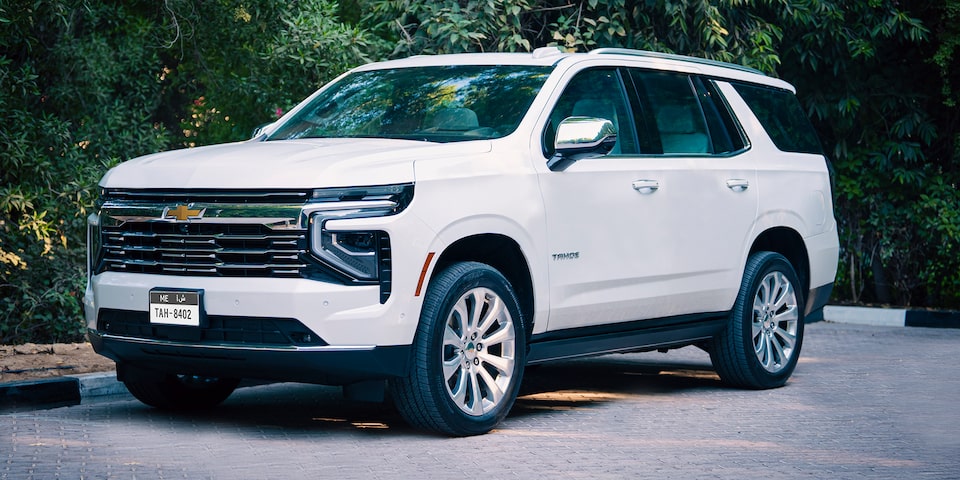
[527, 312, 729, 365]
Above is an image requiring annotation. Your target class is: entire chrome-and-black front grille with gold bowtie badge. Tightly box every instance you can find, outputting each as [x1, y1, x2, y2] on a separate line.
[88, 185, 400, 303]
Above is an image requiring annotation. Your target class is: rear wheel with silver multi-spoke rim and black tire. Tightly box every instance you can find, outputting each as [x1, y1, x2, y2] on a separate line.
[709, 252, 804, 389]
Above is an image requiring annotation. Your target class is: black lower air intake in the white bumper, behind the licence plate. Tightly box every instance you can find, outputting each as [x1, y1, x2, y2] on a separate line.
[97, 308, 327, 346]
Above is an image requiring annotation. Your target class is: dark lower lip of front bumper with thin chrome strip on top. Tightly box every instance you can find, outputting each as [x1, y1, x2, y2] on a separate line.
[88, 329, 410, 385]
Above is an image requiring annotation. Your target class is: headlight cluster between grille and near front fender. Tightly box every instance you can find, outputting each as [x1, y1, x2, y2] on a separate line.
[303, 185, 413, 281]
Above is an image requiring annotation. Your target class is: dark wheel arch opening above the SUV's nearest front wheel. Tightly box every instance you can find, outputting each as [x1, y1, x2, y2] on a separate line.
[430, 233, 534, 336]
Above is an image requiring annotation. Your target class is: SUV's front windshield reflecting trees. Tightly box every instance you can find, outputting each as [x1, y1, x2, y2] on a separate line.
[268, 65, 550, 142]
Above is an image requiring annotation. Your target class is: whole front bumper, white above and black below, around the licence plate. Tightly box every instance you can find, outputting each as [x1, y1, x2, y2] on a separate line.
[84, 272, 418, 385]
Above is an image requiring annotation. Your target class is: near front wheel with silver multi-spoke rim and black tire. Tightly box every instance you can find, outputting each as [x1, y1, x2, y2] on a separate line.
[390, 262, 526, 436]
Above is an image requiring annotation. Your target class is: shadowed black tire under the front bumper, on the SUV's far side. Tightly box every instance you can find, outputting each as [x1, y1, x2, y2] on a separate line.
[123, 368, 240, 411]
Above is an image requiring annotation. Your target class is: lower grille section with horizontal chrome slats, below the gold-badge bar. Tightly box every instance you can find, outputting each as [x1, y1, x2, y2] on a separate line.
[101, 222, 306, 278]
